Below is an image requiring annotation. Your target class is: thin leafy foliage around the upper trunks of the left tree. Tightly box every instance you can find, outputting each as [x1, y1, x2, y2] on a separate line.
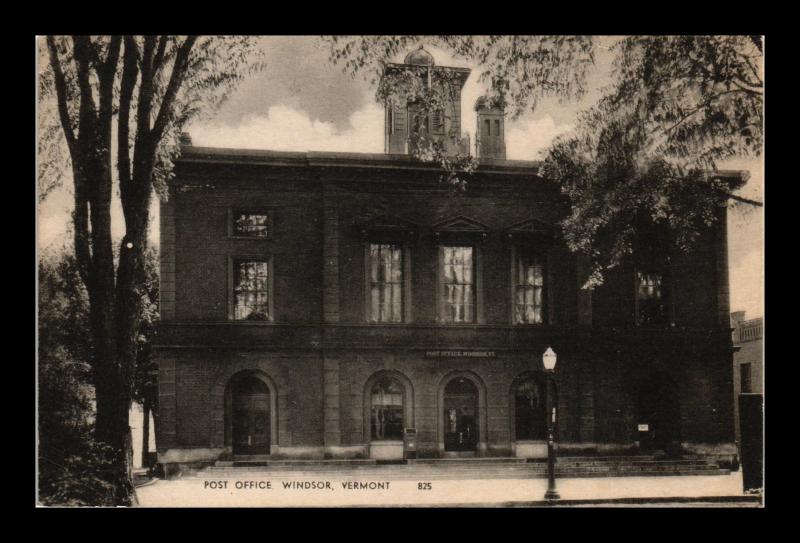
[38, 36, 265, 201]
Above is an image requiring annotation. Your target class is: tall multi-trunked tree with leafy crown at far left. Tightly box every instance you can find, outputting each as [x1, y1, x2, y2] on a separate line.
[39, 36, 260, 505]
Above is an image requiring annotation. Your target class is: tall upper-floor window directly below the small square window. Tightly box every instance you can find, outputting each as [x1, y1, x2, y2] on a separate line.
[233, 259, 271, 321]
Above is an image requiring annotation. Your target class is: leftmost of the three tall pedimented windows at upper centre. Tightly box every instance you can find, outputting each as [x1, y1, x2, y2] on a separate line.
[368, 243, 403, 322]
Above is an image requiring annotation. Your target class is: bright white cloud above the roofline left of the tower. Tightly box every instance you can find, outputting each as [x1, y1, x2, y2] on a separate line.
[189, 104, 384, 153]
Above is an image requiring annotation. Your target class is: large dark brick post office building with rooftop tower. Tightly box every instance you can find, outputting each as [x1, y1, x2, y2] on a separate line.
[154, 50, 741, 472]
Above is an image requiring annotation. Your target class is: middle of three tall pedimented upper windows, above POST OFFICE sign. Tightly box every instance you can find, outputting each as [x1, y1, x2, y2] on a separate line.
[439, 247, 475, 323]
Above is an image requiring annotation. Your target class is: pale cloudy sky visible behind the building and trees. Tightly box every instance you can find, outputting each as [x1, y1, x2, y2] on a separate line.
[38, 36, 764, 318]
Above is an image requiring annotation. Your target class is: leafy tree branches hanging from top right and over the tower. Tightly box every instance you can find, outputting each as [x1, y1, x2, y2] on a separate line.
[326, 36, 763, 284]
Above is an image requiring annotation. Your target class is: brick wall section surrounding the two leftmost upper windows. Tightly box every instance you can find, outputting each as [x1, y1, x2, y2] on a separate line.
[174, 164, 323, 322]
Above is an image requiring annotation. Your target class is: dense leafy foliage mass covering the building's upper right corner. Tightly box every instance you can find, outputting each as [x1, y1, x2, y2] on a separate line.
[542, 36, 763, 284]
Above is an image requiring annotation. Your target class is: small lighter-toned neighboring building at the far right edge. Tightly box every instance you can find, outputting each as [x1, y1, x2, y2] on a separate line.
[731, 311, 764, 442]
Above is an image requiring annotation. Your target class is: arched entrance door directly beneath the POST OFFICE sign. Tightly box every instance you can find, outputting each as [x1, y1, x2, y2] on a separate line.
[444, 378, 478, 451]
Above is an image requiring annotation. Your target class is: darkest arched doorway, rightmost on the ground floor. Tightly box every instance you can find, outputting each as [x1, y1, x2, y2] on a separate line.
[638, 372, 680, 451]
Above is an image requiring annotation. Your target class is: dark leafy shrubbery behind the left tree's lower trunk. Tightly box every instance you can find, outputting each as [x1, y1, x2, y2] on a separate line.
[38, 249, 158, 505]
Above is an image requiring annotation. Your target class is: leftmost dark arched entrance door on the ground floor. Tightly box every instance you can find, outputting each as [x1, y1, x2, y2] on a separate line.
[232, 376, 270, 454]
